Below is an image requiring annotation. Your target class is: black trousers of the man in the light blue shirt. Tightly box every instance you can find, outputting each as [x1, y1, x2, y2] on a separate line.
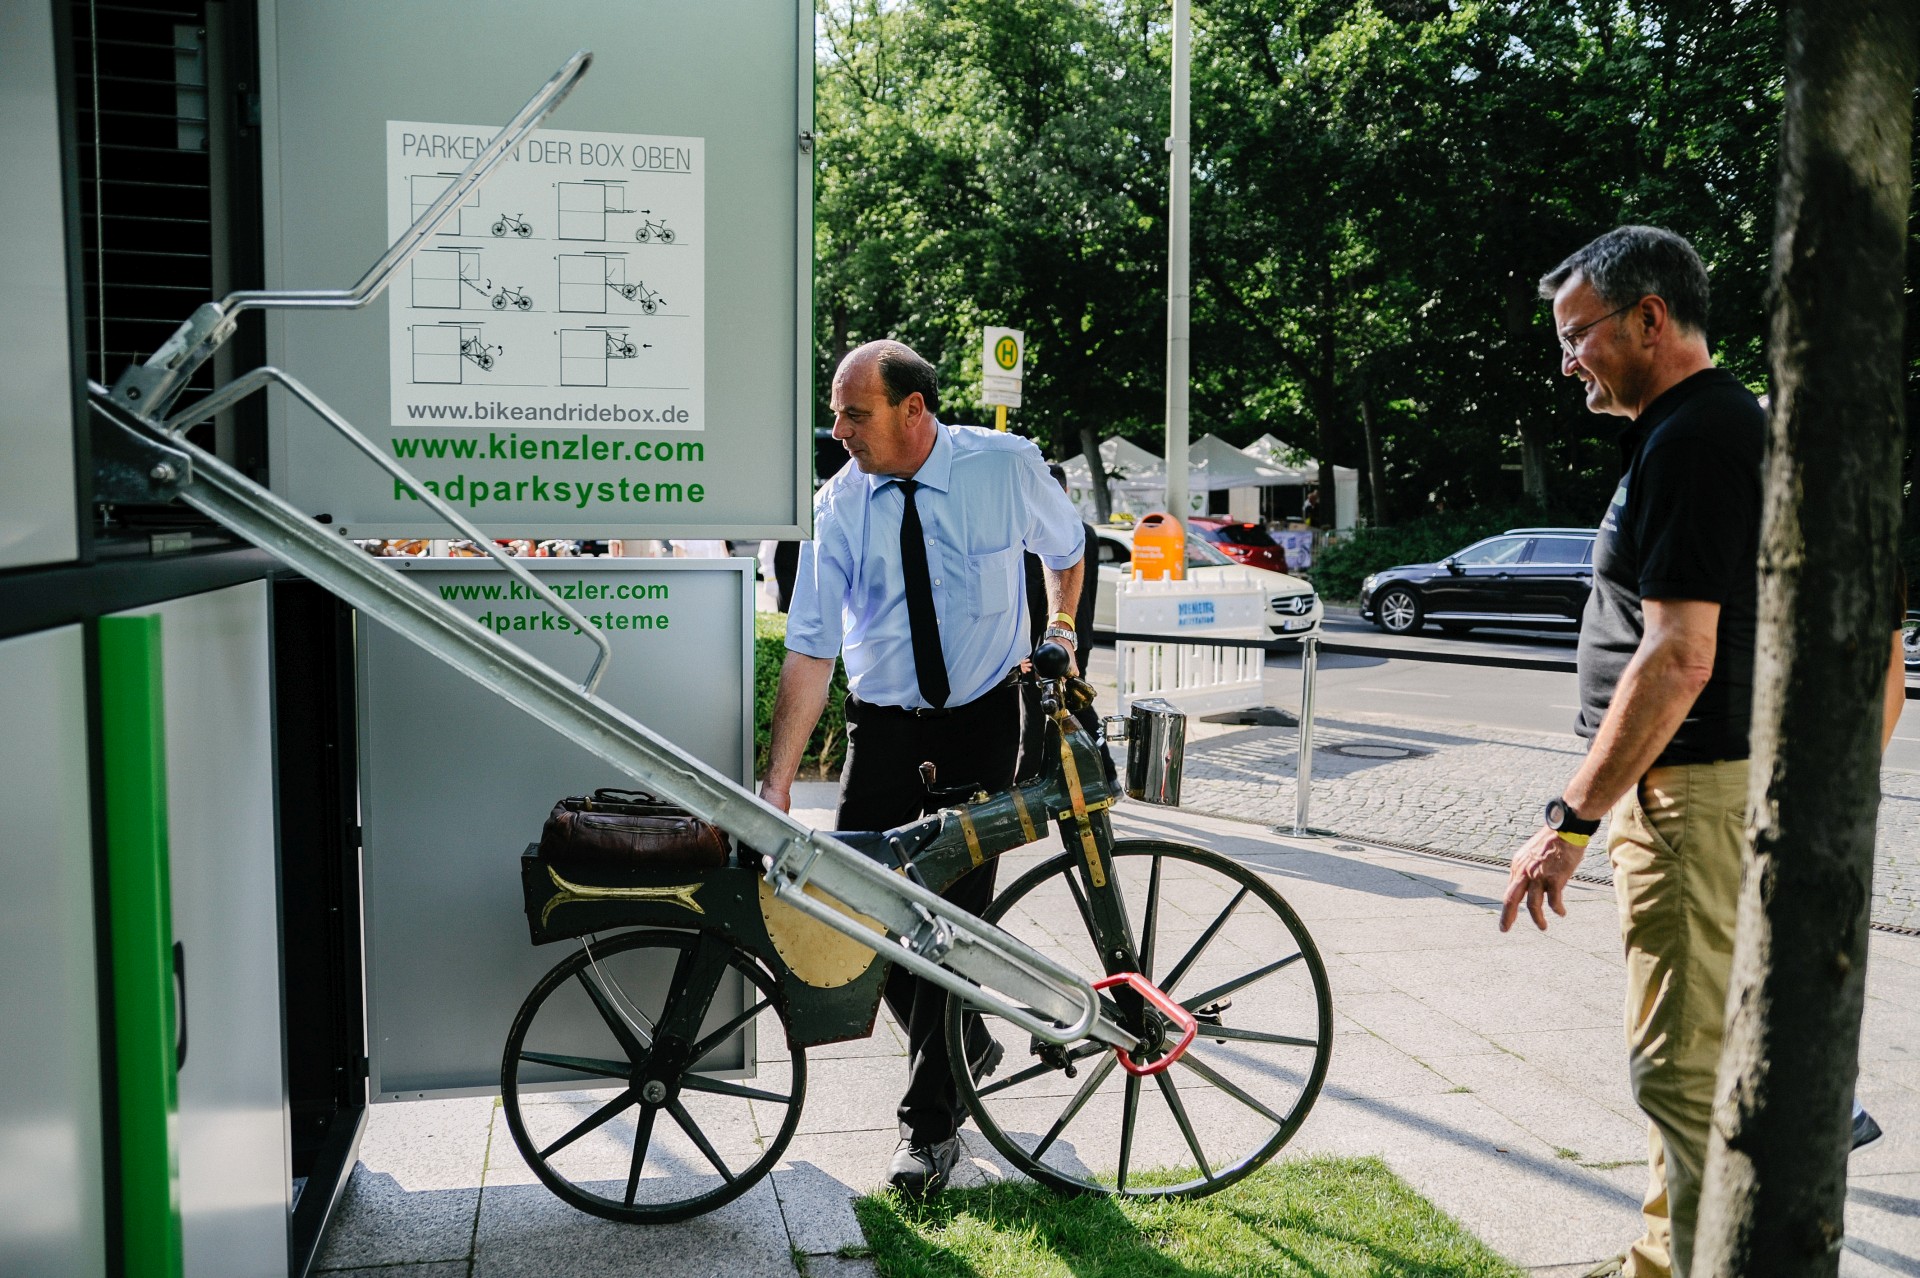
[835, 685, 1020, 1146]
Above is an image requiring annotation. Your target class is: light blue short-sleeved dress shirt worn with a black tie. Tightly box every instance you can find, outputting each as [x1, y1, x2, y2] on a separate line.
[787, 422, 1092, 708]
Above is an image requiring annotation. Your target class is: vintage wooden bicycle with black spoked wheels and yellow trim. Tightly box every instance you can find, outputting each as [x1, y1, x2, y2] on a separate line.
[501, 647, 1332, 1222]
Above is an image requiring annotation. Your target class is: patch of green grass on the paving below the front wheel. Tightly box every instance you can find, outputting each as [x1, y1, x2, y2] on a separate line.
[854, 1157, 1519, 1278]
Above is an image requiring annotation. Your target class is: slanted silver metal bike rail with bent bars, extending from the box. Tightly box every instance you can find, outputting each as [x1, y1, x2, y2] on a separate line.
[88, 52, 1139, 1050]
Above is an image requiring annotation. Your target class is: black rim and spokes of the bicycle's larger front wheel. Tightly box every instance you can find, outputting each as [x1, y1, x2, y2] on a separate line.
[947, 839, 1332, 1197]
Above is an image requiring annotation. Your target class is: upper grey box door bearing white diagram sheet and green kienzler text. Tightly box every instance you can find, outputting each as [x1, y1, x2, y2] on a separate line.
[253, 0, 810, 539]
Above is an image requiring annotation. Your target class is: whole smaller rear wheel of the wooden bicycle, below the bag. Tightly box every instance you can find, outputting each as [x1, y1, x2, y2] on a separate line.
[501, 931, 806, 1224]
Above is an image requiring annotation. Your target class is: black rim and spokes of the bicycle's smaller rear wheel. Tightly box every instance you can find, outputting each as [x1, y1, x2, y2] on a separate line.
[501, 931, 806, 1224]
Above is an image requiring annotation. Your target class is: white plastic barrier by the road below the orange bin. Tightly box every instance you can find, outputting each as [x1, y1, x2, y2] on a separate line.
[1114, 568, 1271, 714]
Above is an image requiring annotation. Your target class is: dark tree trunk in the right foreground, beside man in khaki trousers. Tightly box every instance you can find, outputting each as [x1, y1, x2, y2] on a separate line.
[1690, 0, 1920, 1278]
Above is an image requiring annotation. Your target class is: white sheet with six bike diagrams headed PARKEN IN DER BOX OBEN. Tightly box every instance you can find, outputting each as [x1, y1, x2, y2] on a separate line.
[386, 121, 707, 433]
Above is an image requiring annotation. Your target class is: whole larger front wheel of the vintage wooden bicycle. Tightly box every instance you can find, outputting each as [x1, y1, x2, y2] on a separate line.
[947, 840, 1332, 1197]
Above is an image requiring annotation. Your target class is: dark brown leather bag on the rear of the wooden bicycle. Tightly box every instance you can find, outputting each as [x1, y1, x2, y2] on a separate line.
[540, 787, 728, 873]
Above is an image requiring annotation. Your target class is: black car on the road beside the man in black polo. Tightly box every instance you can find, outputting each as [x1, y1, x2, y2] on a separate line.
[1359, 528, 1594, 635]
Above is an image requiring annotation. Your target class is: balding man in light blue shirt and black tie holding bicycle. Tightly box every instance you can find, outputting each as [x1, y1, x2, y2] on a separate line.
[760, 342, 1083, 1194]
